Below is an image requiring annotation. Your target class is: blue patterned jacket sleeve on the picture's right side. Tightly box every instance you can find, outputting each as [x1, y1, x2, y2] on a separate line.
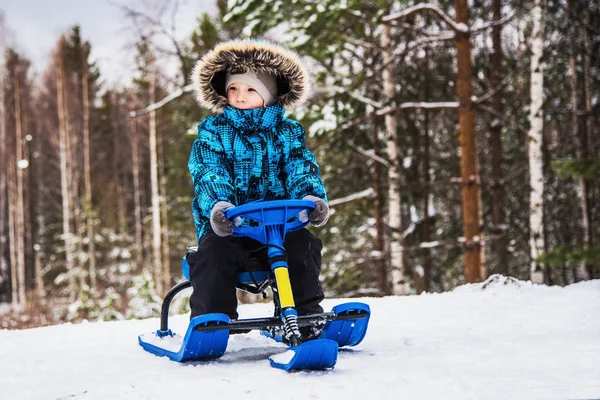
[284, 120, 327, 201]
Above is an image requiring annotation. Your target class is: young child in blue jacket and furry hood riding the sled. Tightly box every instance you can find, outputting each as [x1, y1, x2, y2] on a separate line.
[188, 40, 329, 334]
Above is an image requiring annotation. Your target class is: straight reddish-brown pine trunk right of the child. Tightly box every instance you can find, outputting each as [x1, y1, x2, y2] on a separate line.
[454, 0, 483, 283]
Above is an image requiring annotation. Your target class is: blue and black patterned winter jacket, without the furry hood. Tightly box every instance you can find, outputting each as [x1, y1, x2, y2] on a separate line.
[188, 103, 327, 242]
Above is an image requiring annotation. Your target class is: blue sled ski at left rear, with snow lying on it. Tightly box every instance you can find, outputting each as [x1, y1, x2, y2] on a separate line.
[138, 313, 229, 362]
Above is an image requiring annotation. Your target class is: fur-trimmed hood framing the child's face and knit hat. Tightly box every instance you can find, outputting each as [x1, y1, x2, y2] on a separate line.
[192, 40, 310, 112]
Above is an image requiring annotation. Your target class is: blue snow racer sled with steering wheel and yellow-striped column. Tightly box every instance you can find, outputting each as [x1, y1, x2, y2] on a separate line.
[139, 200, 370, 371]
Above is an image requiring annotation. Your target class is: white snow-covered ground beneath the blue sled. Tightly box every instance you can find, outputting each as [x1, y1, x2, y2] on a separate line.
[0, 278, 600, 400]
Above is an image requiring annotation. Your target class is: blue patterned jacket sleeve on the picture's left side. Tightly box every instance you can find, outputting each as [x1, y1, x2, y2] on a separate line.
[188, 117, 237, 218]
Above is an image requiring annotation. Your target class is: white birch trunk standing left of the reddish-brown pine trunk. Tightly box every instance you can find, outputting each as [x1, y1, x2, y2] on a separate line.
[381, 24, 406, 295]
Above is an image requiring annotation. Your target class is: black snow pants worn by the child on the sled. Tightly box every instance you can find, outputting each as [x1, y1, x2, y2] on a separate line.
[187, 229, 323, 319]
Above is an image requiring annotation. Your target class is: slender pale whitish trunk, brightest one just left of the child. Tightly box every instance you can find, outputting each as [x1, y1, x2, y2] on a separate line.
[149, 72, 163, 294]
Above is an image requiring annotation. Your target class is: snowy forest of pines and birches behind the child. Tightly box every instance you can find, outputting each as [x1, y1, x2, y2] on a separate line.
[0, 0, 600, 328]
